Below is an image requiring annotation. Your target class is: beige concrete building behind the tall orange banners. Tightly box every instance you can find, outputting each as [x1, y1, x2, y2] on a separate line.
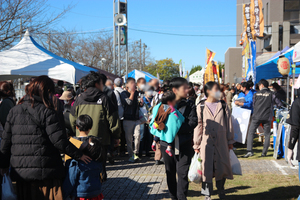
[225, 0, 300, 82]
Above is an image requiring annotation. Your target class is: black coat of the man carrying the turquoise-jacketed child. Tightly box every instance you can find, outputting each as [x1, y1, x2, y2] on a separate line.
[161, 99, 198, 150]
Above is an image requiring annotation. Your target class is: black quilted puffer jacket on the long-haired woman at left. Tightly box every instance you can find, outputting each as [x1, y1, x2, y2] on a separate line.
[0, 97, 82, 181]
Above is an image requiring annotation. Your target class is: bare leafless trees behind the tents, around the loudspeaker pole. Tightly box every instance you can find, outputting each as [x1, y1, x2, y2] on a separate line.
[38, 29, 153, 75]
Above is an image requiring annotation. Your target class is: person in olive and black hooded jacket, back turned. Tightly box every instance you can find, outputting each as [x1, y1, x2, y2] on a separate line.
[69, 71, 121, 181]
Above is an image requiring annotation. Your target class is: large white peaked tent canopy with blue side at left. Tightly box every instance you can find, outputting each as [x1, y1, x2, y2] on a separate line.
[0, 30, 97, 84]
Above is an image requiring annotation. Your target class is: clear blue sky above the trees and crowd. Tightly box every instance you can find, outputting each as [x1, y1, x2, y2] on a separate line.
[48, 0, 236, 70]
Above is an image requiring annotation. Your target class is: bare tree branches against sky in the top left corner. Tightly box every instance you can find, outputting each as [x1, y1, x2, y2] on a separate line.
[0, 0, 71, 50]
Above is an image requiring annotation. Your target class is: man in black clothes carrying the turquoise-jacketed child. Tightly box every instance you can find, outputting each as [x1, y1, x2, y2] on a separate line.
[160, 77, 198, 200]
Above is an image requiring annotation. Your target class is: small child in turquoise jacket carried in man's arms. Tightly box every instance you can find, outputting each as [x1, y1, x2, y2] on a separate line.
[150, 91, 184, 156]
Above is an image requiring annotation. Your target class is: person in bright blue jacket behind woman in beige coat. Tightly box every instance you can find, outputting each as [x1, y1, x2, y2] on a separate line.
[234, 82, 254, 113]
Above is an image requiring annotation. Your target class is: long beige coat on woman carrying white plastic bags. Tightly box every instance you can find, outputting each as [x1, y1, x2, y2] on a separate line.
[194, 102, 234, 183]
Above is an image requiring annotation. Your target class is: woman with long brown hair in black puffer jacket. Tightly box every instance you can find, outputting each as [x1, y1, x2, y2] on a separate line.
[0, 76, 90, 200]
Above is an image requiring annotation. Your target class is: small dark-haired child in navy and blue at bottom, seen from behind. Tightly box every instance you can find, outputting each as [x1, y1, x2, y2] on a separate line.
[63, 115, 104, 200]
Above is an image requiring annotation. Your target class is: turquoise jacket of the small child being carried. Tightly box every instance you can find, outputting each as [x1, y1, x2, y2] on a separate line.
[149, 103, 184, 143]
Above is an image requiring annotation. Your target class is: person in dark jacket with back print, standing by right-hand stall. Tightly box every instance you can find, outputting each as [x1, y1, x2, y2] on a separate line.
[244, 79, 282, 158]
